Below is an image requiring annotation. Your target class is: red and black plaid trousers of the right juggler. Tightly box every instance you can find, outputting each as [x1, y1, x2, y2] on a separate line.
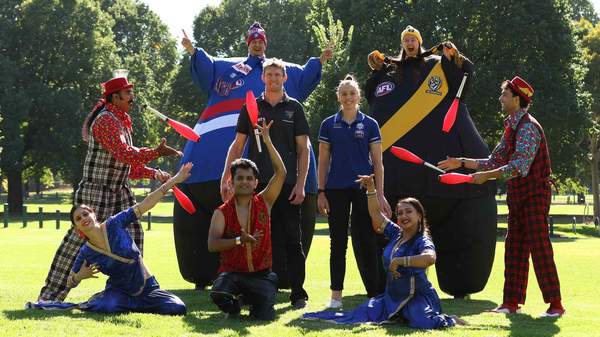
[504, 191, 561, 304]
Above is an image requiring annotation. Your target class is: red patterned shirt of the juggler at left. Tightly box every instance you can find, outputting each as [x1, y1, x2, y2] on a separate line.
[92, 103, 159, 179]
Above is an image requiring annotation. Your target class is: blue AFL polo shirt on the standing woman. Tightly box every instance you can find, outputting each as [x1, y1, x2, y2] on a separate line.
[319, 111, 381, 189]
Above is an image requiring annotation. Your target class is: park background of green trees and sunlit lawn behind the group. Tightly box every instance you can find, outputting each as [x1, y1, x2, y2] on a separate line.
[0, 0, 600, 336]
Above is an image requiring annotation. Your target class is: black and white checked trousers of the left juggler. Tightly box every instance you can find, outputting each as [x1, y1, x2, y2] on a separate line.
[38, 182, 144, 301]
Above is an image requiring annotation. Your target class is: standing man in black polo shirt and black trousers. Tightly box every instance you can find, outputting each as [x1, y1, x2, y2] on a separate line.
[221, 58, 309, 309]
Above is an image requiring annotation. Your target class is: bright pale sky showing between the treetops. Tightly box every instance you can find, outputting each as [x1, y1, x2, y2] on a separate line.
[142, 0, 600, 41]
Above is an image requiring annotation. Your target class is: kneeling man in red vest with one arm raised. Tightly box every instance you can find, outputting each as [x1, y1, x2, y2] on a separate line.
[208, 121, 286, 320]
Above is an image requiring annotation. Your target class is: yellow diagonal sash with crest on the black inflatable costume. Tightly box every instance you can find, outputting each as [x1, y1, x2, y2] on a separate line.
[381, 62, 448, 151]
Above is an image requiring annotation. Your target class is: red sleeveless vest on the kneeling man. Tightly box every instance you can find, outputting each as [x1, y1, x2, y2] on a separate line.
[219, 194, 273, 272]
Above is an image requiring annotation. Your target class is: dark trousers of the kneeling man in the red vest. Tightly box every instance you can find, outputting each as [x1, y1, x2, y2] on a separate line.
[210, 270, 277, 321]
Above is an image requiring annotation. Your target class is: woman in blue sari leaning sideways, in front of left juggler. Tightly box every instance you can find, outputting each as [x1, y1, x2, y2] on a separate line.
[26, 163, 192, 315]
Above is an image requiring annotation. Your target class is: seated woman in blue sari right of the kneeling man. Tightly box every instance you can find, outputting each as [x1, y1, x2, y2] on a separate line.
[303, 175, 465, 329]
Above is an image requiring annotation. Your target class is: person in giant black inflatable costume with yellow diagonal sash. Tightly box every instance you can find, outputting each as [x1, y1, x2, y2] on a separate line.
[365, 26, 496, 297]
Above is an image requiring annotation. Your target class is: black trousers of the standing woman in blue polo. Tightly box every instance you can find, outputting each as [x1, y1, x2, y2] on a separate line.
[325, 188, 386, 297]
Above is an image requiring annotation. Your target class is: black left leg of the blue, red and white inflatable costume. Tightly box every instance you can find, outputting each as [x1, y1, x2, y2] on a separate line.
[173, 180, 223, 288]
